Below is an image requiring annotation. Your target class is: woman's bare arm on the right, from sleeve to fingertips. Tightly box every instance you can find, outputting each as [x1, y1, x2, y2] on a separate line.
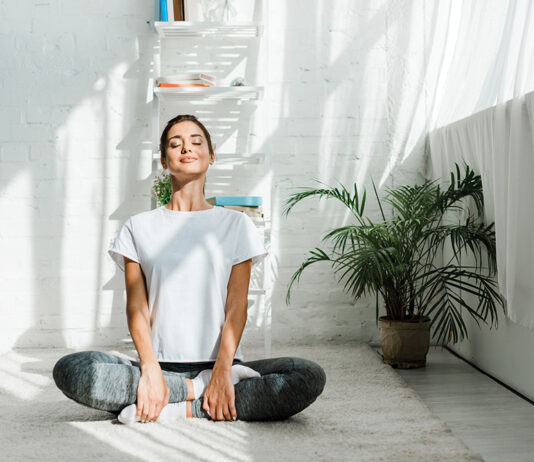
[202, 259, 252, 420]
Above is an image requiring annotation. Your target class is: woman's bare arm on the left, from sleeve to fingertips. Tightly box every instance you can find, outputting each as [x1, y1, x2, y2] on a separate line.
[124, 257, 170, 421]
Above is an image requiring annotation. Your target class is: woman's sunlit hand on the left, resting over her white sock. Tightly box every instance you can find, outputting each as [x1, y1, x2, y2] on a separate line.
[136, 363, 170, 422]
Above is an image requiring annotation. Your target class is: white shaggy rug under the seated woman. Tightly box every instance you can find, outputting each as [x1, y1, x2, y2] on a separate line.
[0, 342, 483, 462]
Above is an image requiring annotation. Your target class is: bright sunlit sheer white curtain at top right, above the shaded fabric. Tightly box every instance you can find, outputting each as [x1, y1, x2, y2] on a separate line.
[424, 0, 534, 132]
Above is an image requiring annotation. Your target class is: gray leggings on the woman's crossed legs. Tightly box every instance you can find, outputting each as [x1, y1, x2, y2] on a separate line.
[53, 351, 326, 421]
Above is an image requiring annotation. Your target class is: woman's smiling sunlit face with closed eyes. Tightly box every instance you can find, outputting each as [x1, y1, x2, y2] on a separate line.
[164, 120, 213, 177]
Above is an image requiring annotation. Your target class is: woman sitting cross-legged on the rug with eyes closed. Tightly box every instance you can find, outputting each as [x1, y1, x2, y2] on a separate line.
[53, 115, 326, 423]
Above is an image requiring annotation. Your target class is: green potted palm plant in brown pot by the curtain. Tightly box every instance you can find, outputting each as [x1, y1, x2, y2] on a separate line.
[284, 164, 504, 368]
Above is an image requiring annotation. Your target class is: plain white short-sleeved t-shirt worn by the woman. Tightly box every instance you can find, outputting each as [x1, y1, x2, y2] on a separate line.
[108, 206, 268, 362]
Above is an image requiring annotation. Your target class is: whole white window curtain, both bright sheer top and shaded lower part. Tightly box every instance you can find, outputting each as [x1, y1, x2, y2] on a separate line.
[425, 0, 534, 329]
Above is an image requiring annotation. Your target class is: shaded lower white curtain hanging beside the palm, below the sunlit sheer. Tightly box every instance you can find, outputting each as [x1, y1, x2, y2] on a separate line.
[429, 92, 534, 329]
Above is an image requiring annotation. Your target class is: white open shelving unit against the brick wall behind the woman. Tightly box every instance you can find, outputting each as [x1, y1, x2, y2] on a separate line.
[151, 21, 271, 357]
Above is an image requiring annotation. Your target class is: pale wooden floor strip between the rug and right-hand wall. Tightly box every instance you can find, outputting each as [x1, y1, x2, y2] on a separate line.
[375, 346, 534, 462]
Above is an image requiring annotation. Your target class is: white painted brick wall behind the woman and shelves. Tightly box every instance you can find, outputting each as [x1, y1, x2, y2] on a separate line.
[0, 0, 425, 351]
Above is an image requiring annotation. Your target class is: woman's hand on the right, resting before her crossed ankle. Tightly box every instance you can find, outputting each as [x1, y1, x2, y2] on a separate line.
[202, 365, 237, 420]
